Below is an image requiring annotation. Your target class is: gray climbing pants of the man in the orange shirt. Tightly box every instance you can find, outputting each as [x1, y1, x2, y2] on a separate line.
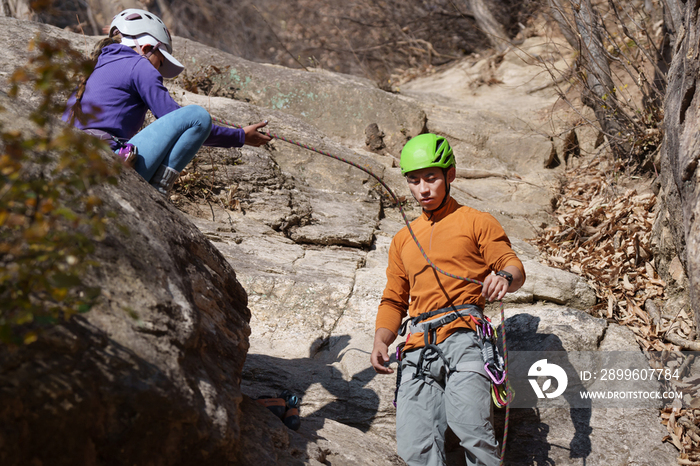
[396, 331, 500, 466]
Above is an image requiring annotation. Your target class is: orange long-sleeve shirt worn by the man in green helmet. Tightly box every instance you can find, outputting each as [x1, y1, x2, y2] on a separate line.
[375, 198, 525, 350]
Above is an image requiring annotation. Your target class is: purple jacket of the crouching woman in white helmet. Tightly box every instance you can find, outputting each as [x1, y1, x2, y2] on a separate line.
[63, 44, 245, 147]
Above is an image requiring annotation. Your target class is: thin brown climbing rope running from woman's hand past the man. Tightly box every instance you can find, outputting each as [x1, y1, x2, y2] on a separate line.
[211, 115, 512, 465]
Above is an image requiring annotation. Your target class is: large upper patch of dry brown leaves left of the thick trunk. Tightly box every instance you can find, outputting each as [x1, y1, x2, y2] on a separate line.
[533, 157, 680, 351]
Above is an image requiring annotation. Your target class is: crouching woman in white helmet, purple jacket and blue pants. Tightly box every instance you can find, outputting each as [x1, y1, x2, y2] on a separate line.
[63, 8, 270, 195]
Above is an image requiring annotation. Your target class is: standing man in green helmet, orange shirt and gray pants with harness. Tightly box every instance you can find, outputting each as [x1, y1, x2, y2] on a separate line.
[371, 134, 525, 466]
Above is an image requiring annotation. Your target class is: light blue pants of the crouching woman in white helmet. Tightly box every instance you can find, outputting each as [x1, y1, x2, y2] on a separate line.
[129, 105, 211, 181]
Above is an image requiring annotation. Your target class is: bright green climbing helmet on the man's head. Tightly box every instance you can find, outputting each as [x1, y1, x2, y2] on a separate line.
[401, 133, 455, 175]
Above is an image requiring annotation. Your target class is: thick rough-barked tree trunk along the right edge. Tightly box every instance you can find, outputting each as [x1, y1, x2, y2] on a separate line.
[659, 2, 700, 326]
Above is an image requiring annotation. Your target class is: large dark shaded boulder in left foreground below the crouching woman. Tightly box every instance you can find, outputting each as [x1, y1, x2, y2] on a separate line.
[0, 93, 253, 465]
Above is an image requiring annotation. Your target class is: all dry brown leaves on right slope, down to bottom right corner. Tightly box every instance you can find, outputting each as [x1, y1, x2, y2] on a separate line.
[532, 157, 700, 458]
